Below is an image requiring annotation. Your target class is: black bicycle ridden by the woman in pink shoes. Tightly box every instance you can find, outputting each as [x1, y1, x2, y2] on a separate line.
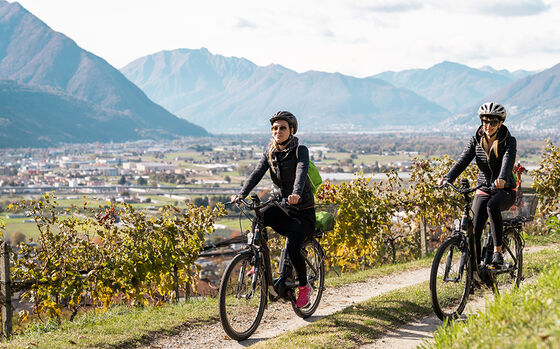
[219, 195, 332, 341]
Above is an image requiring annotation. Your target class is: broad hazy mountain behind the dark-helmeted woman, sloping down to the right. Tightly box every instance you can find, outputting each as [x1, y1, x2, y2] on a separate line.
[121, 48, 450, 132]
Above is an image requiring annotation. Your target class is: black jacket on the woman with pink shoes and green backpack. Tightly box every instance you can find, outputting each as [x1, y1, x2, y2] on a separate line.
[239, 137, 315, 209]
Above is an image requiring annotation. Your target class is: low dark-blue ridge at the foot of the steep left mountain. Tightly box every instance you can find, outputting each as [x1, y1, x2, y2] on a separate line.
[0, 80, 151, 148]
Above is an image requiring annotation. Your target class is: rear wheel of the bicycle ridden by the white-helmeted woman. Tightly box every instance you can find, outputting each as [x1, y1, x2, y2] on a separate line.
[491, 230, 523, 294]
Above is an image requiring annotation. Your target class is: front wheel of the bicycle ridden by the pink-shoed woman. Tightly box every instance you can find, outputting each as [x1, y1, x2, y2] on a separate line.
[219, 253, 266, 341]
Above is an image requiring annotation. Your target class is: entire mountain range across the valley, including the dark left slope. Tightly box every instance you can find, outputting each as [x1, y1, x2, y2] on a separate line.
[0, 0, 560, 147]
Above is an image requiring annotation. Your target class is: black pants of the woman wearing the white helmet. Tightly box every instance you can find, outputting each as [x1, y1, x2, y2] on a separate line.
[472, 189, 516, 262]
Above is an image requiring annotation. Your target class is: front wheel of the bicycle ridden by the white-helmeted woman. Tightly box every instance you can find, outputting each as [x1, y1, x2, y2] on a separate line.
[430, 237, 472, 321]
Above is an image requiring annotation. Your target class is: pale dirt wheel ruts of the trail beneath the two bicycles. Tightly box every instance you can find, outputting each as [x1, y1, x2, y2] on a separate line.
[141, 246, 551, 349]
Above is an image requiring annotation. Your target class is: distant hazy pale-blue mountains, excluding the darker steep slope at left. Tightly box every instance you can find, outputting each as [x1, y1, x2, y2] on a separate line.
[121, 48, 560, 132]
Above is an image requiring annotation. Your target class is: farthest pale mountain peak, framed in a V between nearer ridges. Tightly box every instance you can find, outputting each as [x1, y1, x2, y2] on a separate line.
[373, 62, 521, 112]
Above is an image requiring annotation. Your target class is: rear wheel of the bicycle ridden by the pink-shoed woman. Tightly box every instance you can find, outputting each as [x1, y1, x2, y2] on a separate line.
[291, 239, 325, 319]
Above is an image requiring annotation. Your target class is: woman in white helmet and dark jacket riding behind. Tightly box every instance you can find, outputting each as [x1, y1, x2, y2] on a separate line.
[438, 102, 517, 268]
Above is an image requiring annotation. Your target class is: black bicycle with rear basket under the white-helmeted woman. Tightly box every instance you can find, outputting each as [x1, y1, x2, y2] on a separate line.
[430, 179, 536, 321]
